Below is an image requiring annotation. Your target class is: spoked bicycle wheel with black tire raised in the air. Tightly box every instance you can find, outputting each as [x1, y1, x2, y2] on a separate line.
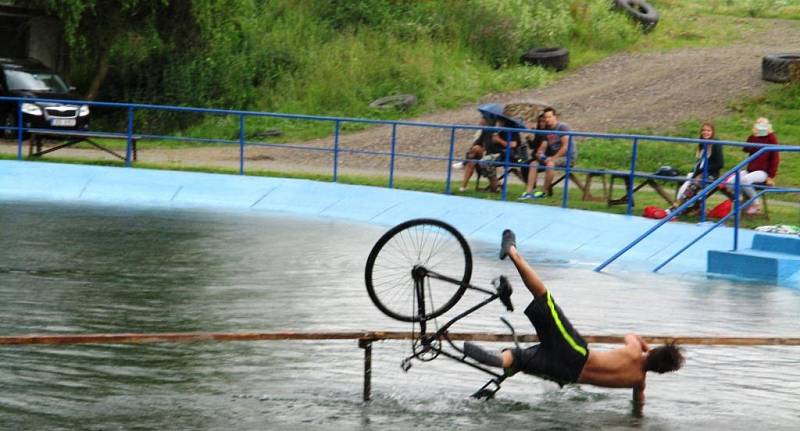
[364, 218, 472, 322]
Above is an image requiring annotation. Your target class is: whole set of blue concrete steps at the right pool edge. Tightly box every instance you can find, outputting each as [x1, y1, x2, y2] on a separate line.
[708, 233, 800, 283]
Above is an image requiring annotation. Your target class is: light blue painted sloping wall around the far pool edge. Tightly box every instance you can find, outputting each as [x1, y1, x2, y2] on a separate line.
[0, 161, 800, 284]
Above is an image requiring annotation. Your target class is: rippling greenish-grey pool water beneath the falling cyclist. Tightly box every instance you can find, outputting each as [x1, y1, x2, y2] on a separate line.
[0, 201, 800, 430]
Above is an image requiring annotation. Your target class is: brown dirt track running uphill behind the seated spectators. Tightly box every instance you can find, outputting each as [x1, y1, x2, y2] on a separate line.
[0, 20, 800, 178]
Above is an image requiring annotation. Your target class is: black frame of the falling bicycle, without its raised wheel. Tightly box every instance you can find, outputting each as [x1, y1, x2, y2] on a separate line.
[401, 266, 516, 398]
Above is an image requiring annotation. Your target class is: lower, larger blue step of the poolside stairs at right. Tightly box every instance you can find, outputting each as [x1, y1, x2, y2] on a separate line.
[708, 249, 800, 282]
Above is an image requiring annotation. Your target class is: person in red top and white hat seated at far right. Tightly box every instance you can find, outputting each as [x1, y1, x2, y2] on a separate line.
[726, 117, 781, 214]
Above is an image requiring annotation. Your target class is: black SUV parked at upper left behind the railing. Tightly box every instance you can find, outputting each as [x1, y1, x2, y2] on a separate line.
[0, 58, 89, 138]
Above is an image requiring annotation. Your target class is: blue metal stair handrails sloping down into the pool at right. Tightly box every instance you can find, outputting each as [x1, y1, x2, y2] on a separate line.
[594, 146, 800, 272]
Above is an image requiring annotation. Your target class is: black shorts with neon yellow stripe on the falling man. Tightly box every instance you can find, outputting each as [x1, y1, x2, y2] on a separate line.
[512, 291, 589, 386]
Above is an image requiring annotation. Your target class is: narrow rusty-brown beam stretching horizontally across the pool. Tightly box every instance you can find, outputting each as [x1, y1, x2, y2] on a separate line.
[0, 331, 800, 346]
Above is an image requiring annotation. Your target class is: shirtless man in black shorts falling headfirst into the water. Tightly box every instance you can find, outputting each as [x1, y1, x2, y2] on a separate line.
[464, 230, 683, 410]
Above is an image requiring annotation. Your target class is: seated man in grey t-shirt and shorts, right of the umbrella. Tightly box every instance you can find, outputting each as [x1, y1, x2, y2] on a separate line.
[519, 107, 578, 199]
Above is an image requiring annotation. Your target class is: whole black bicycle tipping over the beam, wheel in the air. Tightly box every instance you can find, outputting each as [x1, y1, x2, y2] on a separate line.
[364, 218, 519, 398]
